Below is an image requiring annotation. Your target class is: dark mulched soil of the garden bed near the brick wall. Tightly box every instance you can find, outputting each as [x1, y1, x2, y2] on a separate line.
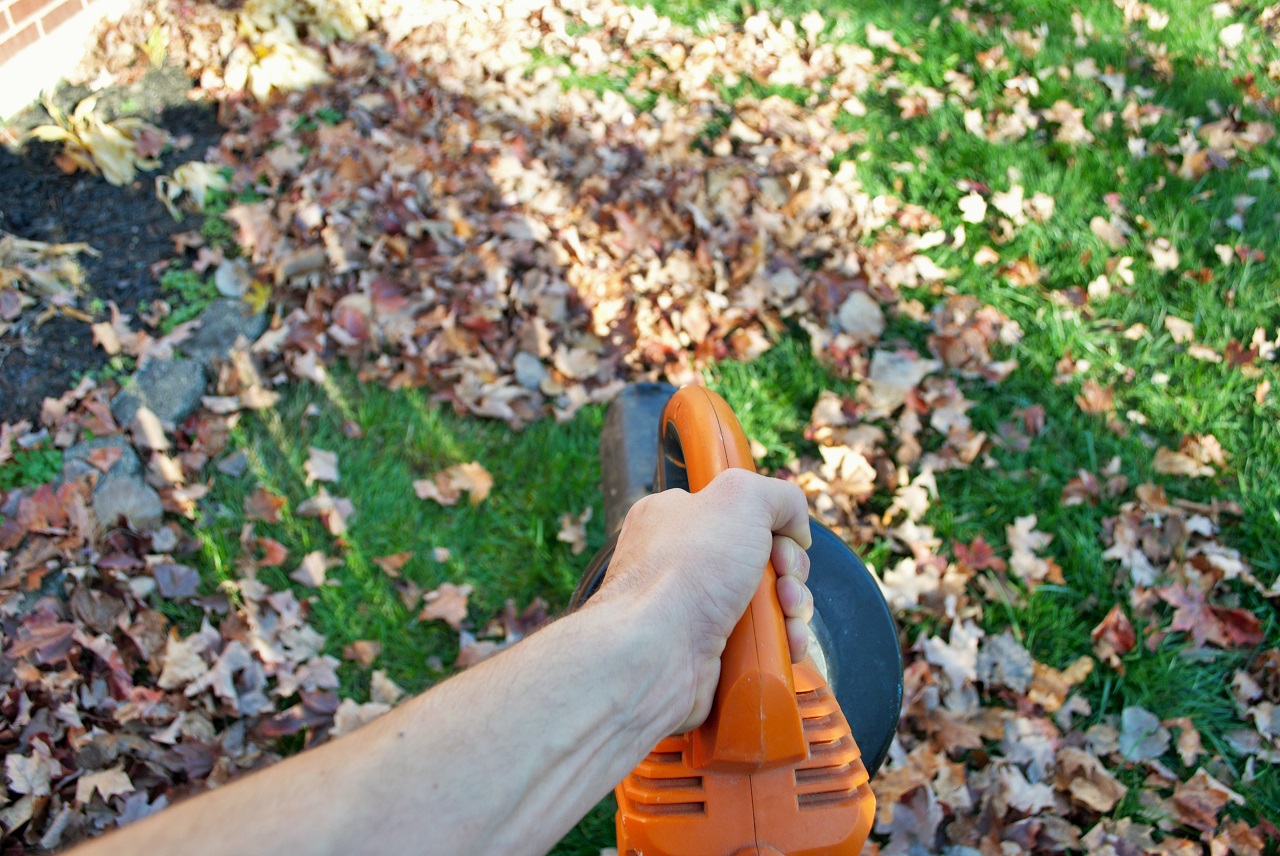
[0, 68, 221, 422]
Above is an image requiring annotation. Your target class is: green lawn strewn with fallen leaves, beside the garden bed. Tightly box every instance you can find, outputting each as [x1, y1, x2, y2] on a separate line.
[0, 0, 1280, 855]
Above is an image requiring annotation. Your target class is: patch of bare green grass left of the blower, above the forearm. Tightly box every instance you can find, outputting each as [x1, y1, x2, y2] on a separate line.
[192, 370, 613, 856]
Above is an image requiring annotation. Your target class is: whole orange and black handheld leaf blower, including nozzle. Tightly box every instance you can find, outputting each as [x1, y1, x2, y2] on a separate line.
[575, 384, 902, 856]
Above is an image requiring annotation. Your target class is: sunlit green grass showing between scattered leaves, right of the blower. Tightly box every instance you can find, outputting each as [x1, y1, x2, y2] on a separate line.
[614, 0, 1280, 820]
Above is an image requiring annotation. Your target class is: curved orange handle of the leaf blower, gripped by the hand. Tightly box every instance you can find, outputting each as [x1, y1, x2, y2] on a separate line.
[660, 386, 806, 773]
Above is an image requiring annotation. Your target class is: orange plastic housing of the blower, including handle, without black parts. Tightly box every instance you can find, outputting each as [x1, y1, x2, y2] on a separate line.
[616, 386, 876, 856]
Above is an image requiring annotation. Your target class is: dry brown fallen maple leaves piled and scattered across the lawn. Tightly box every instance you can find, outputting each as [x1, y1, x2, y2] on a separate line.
[0, 0, 1280, 853]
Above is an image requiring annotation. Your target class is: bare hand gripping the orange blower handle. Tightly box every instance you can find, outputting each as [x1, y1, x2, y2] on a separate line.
[593, 470, 813, 732]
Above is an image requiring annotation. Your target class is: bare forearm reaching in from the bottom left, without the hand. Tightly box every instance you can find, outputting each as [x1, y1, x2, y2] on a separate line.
[78, 604, 687, 856]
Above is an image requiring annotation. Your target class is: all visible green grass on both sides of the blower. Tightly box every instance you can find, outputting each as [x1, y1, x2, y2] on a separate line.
[177, 0, 1280, 839]
